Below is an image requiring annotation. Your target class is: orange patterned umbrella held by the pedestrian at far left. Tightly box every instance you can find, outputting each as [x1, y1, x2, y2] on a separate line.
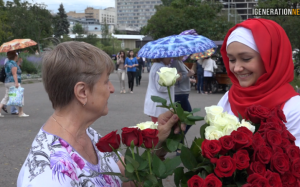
[0, 39, 37, 53]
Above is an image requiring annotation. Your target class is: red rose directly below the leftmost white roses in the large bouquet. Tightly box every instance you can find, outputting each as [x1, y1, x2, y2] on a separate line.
[201, 139, 221, 158]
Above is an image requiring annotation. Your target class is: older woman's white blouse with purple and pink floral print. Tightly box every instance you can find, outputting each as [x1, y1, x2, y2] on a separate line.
[17, 128, 122, 187]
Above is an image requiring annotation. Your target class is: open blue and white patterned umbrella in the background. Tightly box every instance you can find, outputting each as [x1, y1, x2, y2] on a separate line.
[138, 35, 217, 59]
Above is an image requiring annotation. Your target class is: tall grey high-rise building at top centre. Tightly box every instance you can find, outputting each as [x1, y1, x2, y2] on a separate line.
[115, 0, 162, 30]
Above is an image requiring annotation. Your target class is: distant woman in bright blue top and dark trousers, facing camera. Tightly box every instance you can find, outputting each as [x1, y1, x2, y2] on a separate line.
[125, 50, 139, 93]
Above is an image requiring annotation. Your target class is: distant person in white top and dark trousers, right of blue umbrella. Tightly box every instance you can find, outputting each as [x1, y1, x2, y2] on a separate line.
[202, 57, 218, 94]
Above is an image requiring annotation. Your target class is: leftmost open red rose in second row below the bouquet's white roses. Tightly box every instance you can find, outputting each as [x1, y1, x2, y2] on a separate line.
[215, 156, 236, 178]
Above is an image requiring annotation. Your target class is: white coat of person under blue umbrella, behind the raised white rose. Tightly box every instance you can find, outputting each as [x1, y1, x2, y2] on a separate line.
[144, 62, 174, 117]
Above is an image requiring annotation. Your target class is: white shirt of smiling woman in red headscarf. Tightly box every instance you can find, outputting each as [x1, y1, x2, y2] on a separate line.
[218, 92, 300, 146]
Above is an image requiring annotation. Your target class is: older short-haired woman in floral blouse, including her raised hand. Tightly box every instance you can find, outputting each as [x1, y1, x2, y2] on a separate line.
[17, 42, 183, 187]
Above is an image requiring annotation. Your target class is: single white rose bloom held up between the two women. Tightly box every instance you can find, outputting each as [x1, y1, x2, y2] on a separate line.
[157, 67, 180, 87]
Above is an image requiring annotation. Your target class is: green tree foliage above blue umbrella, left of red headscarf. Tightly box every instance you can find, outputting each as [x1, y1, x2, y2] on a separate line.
[142, 0, 233, 40]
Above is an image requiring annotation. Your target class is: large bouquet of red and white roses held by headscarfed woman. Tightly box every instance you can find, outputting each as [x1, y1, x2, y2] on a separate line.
[174, 106, 300, 187]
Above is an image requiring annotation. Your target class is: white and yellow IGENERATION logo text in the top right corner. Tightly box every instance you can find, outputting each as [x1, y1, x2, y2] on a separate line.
[252, 8, 300, 16]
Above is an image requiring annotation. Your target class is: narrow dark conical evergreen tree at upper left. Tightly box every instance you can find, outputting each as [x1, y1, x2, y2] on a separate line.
[54, 3, 70, 37]
